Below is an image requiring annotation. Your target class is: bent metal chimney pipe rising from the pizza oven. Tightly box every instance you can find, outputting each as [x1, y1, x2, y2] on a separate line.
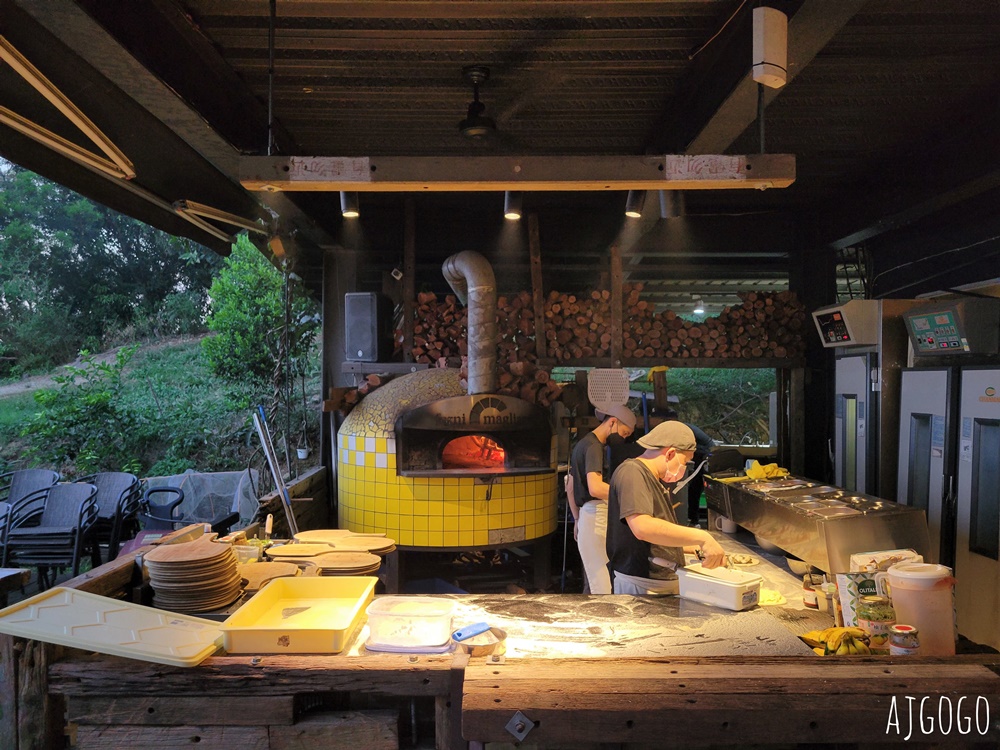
[441, 250, 497, 396]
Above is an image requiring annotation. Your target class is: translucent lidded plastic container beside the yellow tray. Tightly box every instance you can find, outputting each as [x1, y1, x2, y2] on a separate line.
[367, 596, 455, 648]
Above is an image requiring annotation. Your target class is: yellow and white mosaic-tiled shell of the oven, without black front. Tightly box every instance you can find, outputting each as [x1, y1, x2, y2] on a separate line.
[337, 370, 557, 548]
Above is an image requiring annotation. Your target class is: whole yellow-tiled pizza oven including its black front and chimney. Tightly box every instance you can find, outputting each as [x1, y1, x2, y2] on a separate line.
[337, 252, 557, 549]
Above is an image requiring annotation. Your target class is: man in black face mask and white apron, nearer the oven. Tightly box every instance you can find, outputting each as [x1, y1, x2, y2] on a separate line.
[566, 405, 635, 594]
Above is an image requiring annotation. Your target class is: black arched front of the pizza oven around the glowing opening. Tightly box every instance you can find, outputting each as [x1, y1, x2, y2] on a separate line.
[395, 394, 552, 476]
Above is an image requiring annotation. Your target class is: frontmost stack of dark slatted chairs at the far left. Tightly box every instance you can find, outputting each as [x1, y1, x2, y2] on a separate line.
[5, 482, 98, 590]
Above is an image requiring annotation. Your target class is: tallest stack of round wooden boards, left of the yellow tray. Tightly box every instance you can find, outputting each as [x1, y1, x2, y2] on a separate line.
[144, 536, 243, 614]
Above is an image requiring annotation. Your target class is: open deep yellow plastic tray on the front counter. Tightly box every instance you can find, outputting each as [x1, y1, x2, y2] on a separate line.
[222, 576, 378, 654]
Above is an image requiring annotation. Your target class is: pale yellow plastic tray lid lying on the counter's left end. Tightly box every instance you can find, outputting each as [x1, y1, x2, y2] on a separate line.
[0, 586, 222, 667]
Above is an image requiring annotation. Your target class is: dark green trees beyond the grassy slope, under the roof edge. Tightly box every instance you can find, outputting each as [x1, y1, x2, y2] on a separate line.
[0, 160, 221, 374]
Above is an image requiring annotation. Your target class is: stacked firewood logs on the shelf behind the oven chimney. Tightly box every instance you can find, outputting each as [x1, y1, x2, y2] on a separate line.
[378, 284, 806, 405]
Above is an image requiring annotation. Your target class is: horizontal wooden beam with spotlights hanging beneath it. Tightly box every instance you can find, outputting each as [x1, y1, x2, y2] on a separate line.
[240, 154, 795, 192]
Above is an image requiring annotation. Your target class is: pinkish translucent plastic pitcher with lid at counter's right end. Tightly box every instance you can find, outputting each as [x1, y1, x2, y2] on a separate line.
[886, 562, 958, 656]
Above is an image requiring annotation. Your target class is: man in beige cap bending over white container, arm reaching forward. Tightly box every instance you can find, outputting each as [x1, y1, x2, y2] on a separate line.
[607, 421, 725, 595]
